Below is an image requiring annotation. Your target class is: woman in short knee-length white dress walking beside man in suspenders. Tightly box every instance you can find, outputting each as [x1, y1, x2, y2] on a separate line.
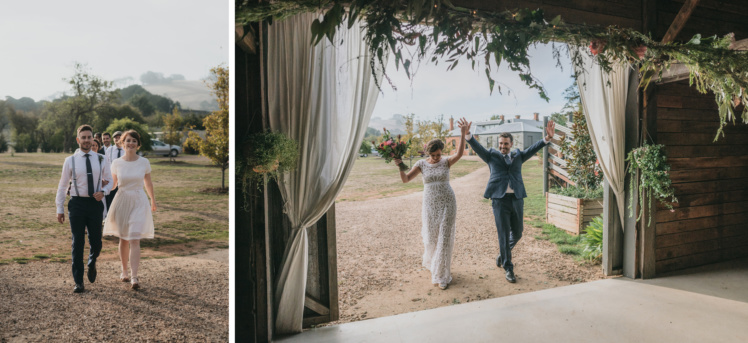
[104, 130, 156, 289]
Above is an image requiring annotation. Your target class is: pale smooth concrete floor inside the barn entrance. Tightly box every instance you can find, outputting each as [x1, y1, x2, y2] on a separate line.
[276, 259, 748, 343]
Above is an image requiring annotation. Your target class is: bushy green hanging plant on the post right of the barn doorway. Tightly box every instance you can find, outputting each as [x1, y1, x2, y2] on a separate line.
[626, 142, 678, 223]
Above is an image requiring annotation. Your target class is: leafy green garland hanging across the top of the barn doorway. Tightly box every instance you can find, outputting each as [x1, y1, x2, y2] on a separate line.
[236, 0, 748, 140]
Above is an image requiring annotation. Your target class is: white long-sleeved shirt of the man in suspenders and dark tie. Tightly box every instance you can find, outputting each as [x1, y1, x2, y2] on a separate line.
[55, 150, 116, 214]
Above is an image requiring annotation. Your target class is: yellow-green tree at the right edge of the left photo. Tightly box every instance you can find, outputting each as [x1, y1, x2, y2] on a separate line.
[185, 65, 229, 189]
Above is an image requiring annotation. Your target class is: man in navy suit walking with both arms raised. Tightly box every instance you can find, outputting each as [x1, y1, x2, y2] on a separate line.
[465, 121, 556, 283]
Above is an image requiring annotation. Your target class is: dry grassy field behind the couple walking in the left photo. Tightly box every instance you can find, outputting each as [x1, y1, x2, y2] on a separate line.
[0, 153, 229, 263]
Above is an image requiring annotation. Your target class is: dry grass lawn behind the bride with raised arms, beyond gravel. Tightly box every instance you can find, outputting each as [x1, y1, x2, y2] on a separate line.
[336, 156, 486, 202]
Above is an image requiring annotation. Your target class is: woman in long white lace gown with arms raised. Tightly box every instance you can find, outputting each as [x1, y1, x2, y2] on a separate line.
[395, 118, 470, 289]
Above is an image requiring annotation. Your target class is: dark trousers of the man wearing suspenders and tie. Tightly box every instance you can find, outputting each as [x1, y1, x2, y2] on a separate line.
[68, 197, 104, 284]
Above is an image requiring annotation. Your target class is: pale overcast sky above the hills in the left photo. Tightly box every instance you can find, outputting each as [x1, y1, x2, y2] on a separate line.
[0, 0, 229, 101]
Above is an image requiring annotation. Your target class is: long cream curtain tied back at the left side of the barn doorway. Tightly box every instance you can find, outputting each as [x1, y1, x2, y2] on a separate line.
[267, 13, 386, 334]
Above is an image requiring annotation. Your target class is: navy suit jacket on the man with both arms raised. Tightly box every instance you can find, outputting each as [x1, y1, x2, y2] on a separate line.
[467, 137, 546, 199]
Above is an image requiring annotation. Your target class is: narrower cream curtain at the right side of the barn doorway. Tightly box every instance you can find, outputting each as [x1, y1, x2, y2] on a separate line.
[574, 47, 631, 227]
